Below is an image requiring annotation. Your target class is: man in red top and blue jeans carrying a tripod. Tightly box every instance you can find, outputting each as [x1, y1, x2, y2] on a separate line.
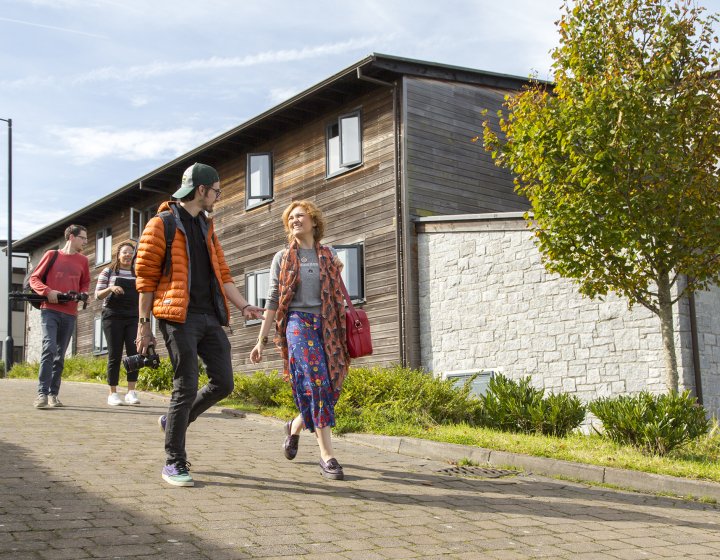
[30, 225, 90, 408]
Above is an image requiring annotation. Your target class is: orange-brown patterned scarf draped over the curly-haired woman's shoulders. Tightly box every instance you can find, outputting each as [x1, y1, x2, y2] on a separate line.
[274, 241, 350, 391]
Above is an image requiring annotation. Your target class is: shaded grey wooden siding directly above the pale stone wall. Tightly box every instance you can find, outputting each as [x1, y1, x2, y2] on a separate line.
[405, 78, 529, 217]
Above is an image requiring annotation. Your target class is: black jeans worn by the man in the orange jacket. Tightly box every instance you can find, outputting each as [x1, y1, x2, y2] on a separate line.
[159, 313, 233, 465]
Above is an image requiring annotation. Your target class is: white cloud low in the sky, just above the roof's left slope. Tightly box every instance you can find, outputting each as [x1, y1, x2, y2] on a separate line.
[50, 127, 214, 165]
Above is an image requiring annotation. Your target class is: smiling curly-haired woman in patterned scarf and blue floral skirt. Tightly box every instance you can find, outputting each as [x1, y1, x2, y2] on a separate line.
[250, 200, 350, 480]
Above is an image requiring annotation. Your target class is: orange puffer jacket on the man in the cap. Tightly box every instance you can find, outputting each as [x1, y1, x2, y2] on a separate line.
[135, 202, 233, 326]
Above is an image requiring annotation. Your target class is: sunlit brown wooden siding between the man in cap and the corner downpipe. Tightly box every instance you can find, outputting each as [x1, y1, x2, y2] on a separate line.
[207, 89, 399, 372]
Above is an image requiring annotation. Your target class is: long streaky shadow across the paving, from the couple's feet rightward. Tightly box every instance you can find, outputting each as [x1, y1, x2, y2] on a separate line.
[195, 461, 720, 531]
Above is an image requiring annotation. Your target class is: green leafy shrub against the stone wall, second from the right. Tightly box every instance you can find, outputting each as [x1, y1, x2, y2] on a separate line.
[480, 374, 585, 437]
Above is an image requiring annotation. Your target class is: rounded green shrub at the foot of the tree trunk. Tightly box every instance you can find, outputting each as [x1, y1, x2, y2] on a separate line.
[590, 391, 710, 455]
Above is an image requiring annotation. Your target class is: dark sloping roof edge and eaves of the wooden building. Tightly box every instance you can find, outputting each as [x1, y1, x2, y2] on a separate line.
[13, 53, 527, 252]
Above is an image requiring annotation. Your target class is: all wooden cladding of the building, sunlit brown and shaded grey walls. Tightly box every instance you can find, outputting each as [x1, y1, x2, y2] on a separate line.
[25, 70, 528, 373]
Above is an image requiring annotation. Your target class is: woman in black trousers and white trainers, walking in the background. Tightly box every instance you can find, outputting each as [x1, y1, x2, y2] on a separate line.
[95, 241, 140, 406]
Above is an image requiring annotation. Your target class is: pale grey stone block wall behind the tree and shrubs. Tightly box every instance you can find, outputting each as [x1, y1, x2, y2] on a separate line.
[417, 214, 720, 413]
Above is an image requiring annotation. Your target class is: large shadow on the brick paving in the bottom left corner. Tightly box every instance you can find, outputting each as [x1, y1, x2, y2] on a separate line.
[0, 426, 251, 560]
